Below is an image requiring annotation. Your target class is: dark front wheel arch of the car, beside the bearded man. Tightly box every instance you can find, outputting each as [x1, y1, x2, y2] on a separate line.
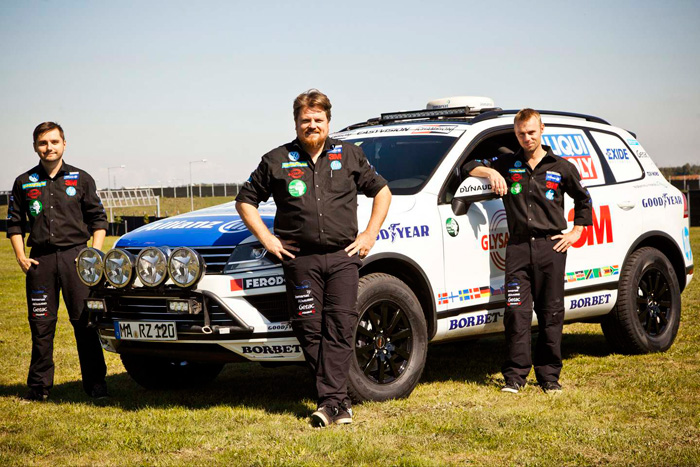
[360, 253, 437, 341]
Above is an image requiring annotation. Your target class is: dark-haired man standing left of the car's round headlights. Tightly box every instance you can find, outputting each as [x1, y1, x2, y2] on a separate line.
[7, 122, 108, 401]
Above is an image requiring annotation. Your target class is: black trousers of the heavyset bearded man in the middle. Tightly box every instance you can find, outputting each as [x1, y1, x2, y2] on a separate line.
[283, 250, 362, 407]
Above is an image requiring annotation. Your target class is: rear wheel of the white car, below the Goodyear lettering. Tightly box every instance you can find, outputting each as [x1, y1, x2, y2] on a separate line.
[601, 247, 681, 354]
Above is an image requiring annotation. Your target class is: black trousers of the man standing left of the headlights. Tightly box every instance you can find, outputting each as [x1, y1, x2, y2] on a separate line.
[26, 245, 107, 394]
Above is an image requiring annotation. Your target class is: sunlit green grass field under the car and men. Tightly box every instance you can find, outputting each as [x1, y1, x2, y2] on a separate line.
[0, 228, 700, 466]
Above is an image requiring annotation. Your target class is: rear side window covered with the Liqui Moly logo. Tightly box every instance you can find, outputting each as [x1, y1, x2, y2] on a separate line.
[542, 126, 605, 187]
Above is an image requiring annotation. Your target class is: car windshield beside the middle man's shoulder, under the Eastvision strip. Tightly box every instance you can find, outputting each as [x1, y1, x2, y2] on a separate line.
[343, 135, 457, 195]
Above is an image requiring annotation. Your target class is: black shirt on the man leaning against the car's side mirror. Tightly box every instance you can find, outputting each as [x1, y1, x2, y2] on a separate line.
[465, 145, 592, 239]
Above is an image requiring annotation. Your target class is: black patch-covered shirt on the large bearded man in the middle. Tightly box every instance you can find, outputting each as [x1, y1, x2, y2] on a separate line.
[236, 138, 386, 250]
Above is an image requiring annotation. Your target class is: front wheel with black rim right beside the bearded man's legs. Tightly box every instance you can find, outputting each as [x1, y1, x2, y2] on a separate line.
[348, 273, 428, 402]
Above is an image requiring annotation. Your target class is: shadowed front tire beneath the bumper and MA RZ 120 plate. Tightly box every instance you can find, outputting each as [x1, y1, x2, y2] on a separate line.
[121, 355, 224, 389]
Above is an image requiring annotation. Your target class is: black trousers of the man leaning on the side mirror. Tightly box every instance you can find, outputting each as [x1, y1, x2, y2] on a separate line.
[502, 237, 566, 384]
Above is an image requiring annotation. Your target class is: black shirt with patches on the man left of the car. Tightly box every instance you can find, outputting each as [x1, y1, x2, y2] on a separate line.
[7, 162, 109, 248]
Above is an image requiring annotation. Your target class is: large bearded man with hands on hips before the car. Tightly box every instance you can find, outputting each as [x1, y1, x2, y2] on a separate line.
[236, 89, 391, 426]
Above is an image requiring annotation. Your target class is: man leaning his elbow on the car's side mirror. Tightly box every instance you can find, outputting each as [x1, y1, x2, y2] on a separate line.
[465, 109, 592, 393]
